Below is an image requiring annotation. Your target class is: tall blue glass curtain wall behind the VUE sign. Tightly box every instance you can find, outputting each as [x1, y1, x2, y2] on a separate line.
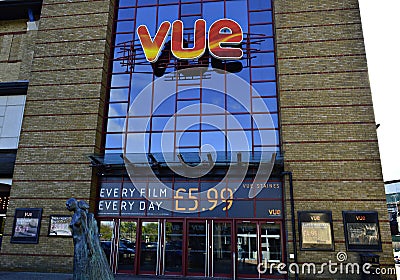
[103, 0, 279, 153]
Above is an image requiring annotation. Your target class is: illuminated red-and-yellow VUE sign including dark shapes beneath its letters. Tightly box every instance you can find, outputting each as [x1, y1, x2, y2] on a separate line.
[137, 18, 243, 76]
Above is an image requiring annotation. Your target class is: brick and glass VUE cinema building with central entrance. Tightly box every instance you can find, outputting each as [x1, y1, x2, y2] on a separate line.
[0, 0, 395, 279]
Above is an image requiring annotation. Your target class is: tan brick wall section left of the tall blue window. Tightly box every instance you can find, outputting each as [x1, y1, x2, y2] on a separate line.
[0, 0, 114, 272]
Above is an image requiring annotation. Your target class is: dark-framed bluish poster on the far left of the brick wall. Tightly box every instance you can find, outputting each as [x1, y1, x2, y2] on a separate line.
[10, 208, 42, 244]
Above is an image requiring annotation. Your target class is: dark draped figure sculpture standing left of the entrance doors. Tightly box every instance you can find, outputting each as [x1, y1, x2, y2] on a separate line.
[66, 198, 114, 280]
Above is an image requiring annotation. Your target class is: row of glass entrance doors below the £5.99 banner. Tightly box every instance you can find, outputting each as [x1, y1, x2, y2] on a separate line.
[100, 218, 282, 278]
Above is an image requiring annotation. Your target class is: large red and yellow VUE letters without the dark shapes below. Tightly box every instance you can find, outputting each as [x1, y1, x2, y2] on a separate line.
[137, 18, 243, 63]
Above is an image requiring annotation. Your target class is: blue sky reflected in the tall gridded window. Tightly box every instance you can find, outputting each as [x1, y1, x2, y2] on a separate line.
[106, 0, 279, 152]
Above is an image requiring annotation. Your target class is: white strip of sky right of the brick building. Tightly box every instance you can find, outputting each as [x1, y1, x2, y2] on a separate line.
[359, 0, 400, 189]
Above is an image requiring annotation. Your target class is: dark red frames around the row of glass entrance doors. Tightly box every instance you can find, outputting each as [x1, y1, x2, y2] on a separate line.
[99, 217, 286, 279]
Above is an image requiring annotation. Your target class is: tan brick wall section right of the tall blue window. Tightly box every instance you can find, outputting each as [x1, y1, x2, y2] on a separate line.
[274, 0, 393, 279]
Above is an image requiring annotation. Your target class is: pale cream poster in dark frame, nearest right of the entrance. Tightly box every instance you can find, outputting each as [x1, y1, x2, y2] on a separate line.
[297, 211, 335, 251]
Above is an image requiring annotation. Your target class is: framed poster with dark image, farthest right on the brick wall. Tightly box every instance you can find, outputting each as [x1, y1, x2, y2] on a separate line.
[343, 211, 382, 251]
